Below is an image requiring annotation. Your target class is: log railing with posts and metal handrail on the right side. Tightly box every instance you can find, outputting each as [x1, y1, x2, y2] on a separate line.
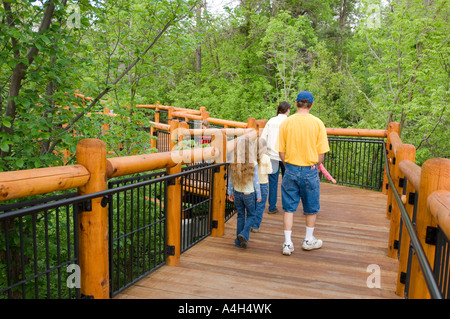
[386, 123, 450, 298]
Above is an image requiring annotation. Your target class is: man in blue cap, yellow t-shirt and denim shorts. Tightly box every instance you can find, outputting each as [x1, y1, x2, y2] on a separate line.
[277, 91, 330, 255]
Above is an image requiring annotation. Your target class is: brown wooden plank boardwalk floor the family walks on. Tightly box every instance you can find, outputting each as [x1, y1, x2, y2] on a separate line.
[116, 183, 399, 299]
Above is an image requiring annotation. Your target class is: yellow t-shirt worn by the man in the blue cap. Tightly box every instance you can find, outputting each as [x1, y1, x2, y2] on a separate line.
[277, 113, 330, 166]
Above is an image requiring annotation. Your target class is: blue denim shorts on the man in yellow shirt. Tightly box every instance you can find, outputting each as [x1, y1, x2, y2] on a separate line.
[281, 163, 320, 215]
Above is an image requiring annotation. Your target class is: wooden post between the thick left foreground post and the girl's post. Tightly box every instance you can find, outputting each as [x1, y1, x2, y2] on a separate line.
[166, 120, 181, 266]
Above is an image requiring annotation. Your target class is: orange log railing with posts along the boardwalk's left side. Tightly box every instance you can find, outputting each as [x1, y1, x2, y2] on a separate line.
[0, 110, 254, 298]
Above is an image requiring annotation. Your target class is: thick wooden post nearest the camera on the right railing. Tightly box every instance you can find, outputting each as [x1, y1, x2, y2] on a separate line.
[408, 158, 450, 299]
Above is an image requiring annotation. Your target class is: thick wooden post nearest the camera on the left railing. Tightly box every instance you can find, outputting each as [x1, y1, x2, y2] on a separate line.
[76, 139, 109, 299]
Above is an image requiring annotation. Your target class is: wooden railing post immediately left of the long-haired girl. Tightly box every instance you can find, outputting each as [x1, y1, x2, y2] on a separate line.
[211, 130, 227, 237]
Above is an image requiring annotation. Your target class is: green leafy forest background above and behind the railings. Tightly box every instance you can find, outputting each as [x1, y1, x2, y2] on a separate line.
[0, 0, 450, 171]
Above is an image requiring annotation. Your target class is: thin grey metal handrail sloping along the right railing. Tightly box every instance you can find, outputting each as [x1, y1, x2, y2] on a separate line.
[384, 145, 442, 299]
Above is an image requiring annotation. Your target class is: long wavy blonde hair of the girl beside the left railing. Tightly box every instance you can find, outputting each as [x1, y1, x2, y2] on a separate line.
[230, 135, 255, 187]
